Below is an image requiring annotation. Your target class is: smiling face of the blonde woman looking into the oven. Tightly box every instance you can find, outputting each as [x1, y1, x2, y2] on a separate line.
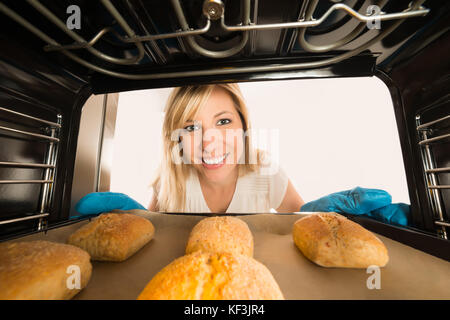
[182, 87, 244, 183]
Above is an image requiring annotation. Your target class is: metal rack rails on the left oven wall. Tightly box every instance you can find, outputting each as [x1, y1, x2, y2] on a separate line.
[0, 107, 62, 231]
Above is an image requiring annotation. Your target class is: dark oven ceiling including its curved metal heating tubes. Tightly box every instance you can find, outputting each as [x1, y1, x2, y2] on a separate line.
[0, 0, 448, 93]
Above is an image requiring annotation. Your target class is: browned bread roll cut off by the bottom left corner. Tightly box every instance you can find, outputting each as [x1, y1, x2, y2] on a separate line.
[0, 241, 92, 300]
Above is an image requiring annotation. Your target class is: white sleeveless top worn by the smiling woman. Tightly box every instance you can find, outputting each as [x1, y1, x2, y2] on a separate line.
[185, 167, 288, 213]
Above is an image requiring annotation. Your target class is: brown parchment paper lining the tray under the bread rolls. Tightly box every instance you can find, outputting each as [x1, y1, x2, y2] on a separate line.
[8, 210, 450, 299]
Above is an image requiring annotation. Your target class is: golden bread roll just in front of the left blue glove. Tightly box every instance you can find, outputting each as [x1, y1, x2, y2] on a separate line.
[67, 213, 155, 261]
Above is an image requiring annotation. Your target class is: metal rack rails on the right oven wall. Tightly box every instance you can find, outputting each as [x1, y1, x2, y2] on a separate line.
[416, 111, 450, 239]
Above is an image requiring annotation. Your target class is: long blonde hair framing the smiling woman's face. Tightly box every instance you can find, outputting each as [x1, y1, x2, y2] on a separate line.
[152, 83, 263, 212]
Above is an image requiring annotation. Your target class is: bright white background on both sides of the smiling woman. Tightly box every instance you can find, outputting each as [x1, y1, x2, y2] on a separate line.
[111, 77, 410, 207]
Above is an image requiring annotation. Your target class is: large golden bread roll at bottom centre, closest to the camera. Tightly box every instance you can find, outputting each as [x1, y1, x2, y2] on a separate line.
[138, 251, 284, 300]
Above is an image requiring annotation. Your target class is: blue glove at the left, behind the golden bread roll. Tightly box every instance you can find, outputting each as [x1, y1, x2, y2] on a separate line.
[75, 192, 146, 214]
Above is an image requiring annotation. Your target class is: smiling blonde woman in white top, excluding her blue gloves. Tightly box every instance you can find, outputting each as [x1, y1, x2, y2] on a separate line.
[149, 83, 304, 213]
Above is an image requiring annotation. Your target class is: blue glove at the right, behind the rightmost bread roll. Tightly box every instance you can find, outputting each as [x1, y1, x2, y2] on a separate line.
[300, 187, 410, 226]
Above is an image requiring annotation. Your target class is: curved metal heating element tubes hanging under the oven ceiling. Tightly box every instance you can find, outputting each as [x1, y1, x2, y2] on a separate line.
[0, 0, 430, 80]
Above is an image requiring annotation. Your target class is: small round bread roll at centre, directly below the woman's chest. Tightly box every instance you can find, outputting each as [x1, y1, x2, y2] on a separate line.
[186, 216, 253, 257]
